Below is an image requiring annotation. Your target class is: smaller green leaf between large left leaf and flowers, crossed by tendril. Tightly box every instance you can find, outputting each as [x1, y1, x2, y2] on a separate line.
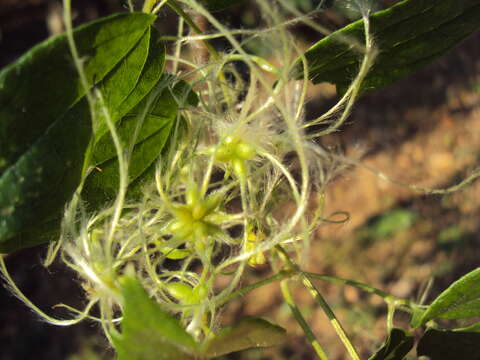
[83, 76, 197, 208]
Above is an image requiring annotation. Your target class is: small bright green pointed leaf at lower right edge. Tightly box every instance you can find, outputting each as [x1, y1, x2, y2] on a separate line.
[412, 268, 480, 327]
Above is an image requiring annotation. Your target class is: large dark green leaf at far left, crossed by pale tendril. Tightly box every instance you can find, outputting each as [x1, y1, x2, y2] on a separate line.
[0, 14, 154, 252]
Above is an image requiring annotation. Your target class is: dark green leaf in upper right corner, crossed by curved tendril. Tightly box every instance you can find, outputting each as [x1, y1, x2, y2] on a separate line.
[295, 0, 480, 93]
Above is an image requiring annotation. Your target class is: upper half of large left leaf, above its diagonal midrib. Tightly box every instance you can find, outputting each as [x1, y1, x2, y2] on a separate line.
[0, 14, 154, 172]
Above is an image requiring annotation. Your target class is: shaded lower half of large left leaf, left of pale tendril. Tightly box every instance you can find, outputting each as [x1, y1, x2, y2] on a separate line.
[0, 97, 91, 252]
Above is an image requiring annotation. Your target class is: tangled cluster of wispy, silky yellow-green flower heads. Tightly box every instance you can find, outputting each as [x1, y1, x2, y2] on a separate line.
[26, 0, 376, 340]
